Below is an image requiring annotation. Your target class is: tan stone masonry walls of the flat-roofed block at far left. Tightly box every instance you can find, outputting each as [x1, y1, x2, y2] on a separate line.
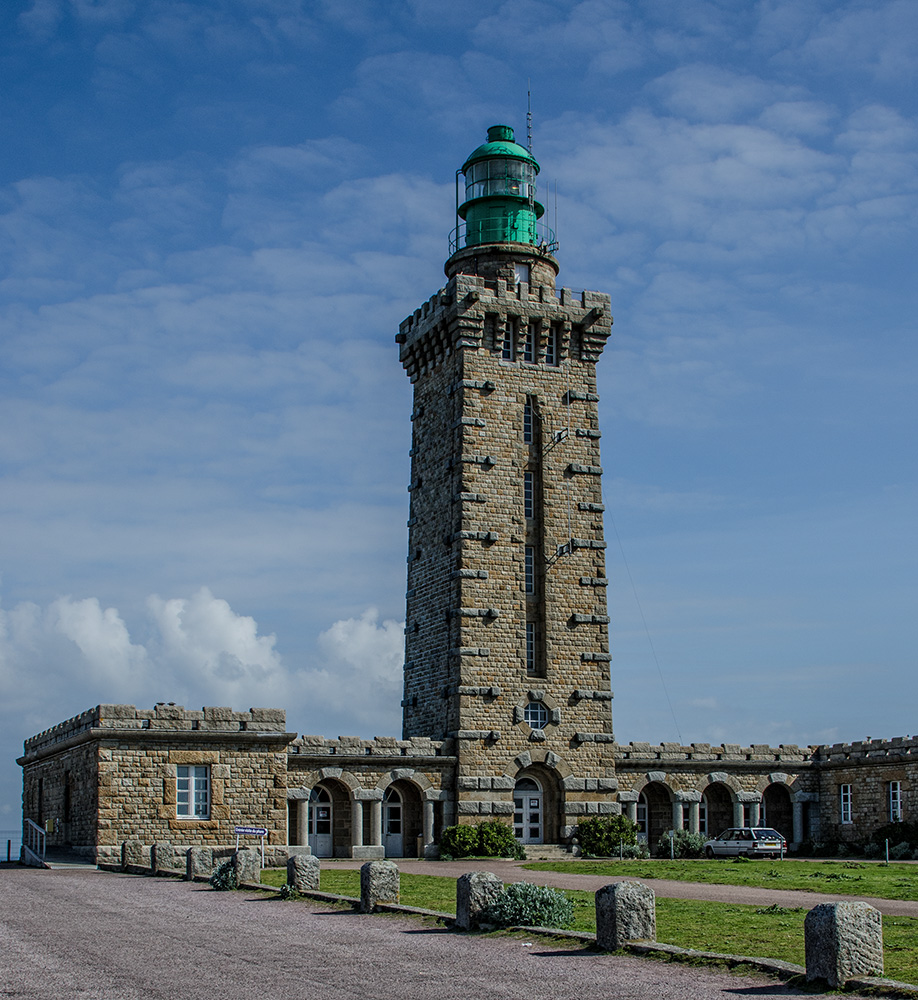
[19, 704, 293, 848]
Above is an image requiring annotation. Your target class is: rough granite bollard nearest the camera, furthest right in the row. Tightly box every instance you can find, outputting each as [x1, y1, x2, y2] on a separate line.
[803, 903, 883, 990]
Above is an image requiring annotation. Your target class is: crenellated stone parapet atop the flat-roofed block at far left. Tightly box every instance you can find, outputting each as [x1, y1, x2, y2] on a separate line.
[23, 702, 286, 754]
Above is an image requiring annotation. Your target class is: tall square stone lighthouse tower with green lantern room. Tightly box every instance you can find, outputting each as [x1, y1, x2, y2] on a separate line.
[396, 125, 619, 843]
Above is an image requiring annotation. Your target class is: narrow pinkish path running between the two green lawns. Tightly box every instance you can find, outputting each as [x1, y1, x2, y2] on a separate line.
[322, 858, 918, 917]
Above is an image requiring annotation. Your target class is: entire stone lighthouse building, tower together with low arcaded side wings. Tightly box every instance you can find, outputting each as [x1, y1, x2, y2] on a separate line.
[20, 126, 918, 858]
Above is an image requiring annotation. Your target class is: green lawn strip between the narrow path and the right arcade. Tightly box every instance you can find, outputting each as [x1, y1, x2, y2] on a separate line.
[524, 858, 918, 899]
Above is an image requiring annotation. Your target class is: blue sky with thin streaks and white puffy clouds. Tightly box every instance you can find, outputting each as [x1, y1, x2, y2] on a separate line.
[0, 0, 918, 826]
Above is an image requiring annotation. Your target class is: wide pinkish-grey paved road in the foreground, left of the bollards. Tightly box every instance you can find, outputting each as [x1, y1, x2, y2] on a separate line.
[0, 868, 880, 1000]
